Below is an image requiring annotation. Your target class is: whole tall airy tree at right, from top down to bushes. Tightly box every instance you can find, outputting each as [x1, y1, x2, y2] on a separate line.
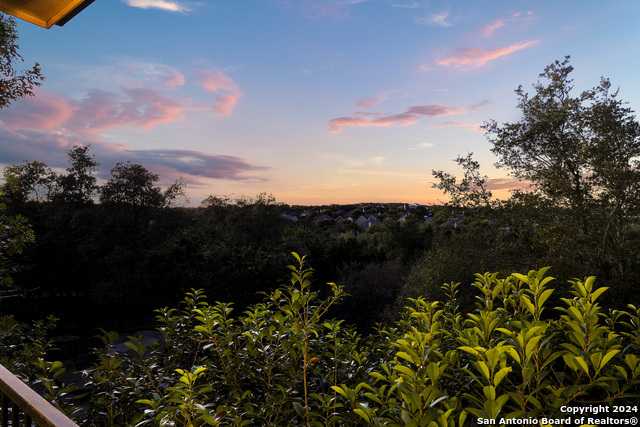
[484, 56, 640, 282]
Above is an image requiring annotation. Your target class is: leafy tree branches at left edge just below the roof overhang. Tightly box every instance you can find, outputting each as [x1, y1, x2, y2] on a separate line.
[0, 13, 44, 109]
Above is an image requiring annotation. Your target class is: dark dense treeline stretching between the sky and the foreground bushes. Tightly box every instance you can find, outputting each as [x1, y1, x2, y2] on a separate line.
[3, 147, 640, 334]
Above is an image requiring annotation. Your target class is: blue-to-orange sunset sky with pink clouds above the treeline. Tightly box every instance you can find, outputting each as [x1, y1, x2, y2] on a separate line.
[0, 0, 640, 205]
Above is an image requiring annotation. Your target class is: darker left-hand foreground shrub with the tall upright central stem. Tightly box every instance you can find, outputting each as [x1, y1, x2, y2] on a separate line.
[77, 256, 364, 425]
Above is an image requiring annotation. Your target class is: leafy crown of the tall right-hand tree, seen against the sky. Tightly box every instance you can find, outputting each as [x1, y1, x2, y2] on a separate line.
[484, 57, 640, 214]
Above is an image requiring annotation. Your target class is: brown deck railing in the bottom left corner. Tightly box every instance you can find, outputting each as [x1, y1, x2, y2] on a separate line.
[0, 365, 78, 427]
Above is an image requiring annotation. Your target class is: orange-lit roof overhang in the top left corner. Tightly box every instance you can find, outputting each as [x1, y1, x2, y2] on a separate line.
[0, 0, 94, 28]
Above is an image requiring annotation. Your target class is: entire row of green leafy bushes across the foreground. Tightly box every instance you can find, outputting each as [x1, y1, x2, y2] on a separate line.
[41, 254, 640, 426]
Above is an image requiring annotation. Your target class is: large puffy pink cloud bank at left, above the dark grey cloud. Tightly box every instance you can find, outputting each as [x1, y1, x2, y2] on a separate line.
[0, 69, 241, 137]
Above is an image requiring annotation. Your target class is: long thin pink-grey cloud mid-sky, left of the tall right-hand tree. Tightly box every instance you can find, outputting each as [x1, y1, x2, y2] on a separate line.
[329, 101, 484, 132]
